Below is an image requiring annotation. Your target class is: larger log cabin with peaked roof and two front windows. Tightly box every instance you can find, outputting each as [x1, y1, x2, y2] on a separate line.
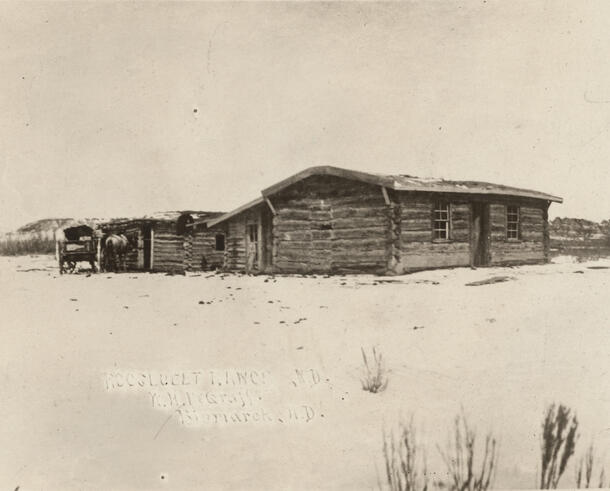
[193, 166, 562, 274]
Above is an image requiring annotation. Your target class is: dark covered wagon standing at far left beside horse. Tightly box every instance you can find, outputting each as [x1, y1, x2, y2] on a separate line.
[55, 225, 101, 274]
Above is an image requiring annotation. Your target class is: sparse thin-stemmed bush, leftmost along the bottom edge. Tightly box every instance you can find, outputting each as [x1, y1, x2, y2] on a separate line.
[383, 417, 428, 491]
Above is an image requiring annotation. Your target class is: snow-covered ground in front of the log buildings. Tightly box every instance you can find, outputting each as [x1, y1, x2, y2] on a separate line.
[0, 257, 610, 490]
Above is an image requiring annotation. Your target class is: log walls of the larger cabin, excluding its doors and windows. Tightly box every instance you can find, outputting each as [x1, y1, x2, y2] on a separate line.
[220, 176, 548, 274]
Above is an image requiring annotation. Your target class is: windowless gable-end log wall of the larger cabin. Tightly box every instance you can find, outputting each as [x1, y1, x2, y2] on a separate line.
[271, 176, 391, 273]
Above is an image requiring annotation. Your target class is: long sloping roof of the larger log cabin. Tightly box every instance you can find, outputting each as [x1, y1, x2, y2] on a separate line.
[195, 165, 563, 227]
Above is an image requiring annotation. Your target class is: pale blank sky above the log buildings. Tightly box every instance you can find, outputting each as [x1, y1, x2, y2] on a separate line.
[0, 1, 610, 230]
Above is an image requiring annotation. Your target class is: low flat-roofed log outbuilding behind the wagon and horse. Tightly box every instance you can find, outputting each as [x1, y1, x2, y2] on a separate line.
[100, 211, 223, 273]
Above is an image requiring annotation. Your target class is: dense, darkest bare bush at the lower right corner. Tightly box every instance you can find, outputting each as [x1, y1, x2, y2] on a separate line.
[540, 404, 578, 489]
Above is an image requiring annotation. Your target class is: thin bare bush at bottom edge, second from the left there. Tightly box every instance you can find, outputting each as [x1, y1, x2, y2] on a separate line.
[438, 410, 498, 491]
